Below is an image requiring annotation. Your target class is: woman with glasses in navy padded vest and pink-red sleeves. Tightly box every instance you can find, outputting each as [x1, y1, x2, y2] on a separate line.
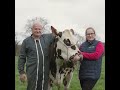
[79, 27, 104, 90]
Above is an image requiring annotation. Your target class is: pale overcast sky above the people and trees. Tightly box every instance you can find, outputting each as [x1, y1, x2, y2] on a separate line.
[15, 0, 105, 42]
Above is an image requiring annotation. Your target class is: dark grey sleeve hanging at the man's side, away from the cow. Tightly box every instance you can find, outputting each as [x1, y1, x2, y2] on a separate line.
[18, 40, 26, 74]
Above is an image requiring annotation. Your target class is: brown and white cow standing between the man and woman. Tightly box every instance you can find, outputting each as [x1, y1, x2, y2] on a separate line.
[48, 26, 82, 90]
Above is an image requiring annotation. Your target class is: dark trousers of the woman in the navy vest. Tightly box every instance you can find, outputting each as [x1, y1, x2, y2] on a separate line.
[80, 79, 98, 90]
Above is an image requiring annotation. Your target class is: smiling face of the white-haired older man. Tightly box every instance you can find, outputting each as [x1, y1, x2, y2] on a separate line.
[32, 23, 42, 37]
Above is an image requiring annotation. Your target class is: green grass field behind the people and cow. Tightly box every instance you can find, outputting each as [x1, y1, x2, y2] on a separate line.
[15, 57, 105, 90]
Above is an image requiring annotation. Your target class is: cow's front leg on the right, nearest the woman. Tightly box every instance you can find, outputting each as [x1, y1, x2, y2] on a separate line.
[64, 72, 73, 90]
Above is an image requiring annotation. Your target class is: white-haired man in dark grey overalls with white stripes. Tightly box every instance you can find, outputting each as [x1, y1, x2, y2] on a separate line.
[18, 18, 54, 90]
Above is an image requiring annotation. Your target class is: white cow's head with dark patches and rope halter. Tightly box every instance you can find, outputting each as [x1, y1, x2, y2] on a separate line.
[51, 26, 79, 60]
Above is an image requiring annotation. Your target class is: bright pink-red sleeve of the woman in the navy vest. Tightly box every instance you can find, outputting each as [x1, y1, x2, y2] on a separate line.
[81, 42, 104, 60]
